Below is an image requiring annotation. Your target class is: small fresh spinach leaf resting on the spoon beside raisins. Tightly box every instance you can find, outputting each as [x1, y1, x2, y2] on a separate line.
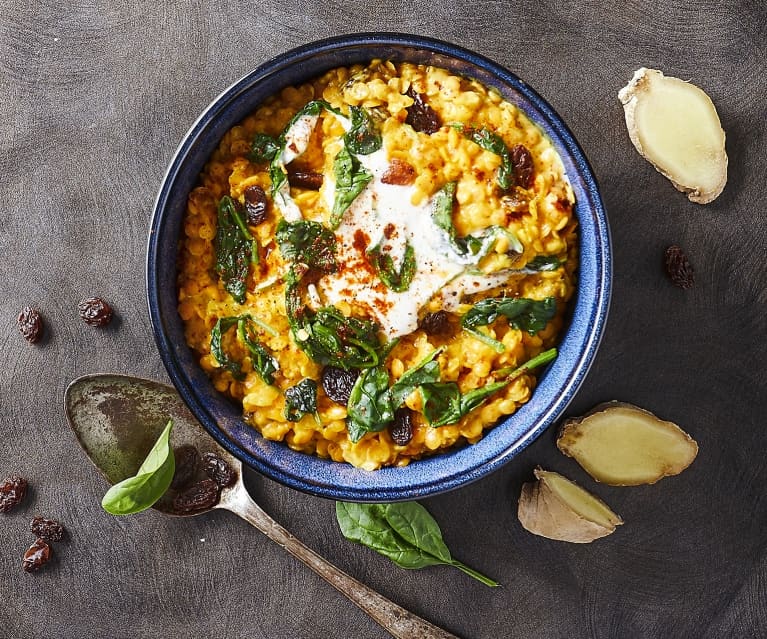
[101, 421, 176, 515]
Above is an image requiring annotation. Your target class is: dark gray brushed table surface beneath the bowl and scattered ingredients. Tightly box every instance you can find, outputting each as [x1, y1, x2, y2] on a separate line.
[0, 0, 767, 639]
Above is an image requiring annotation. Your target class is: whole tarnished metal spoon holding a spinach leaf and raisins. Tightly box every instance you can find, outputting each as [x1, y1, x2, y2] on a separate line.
[64, 375, 458, 639]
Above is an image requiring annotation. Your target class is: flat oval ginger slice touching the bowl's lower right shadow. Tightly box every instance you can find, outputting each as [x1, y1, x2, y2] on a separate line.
[557, 402, 698, 486]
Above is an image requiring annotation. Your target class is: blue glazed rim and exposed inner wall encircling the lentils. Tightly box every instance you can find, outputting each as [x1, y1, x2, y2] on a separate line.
[147, 33, 612, 502]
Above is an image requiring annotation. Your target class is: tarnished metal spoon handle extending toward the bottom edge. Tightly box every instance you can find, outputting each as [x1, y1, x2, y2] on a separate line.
[221, 489, 458, 639]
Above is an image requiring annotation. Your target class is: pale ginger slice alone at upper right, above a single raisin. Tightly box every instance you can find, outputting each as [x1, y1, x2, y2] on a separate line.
[618, 67, 727, 204]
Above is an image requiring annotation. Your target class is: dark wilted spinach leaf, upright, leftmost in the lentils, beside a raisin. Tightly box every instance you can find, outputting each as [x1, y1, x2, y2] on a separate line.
[213, 195, 258, 304]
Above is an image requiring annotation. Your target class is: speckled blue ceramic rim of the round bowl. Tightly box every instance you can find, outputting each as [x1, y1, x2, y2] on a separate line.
[146, 32, 612, 502]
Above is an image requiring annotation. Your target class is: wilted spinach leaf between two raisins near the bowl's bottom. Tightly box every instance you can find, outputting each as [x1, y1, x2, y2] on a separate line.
[346, 366, 394, 442]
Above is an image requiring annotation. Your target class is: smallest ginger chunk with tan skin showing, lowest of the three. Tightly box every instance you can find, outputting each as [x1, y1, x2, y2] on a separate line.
[517, 468, 623, 544]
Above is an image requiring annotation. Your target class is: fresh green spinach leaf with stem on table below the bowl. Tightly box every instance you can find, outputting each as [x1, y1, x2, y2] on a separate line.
[336, 502, 500, 586]
